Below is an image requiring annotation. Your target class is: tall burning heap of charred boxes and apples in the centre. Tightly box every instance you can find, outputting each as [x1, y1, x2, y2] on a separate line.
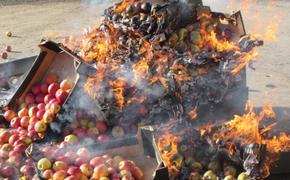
[66, 0, 262, 130]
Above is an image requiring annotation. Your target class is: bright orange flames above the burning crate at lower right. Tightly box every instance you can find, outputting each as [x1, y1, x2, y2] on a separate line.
[210, 103, 290, 177]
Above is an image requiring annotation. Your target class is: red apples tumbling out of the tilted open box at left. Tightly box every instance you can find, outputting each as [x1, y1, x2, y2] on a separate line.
[4, 75, 73, 140]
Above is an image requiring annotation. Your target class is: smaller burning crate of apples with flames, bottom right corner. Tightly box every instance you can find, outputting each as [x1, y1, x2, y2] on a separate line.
[156, 104, 290, 180]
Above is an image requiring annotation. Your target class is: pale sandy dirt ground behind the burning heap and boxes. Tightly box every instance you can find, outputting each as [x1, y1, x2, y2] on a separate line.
[0, 0, 290, 108]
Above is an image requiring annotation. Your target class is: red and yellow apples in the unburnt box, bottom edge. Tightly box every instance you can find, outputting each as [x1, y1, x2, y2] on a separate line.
[37, 147, 144, 180]
